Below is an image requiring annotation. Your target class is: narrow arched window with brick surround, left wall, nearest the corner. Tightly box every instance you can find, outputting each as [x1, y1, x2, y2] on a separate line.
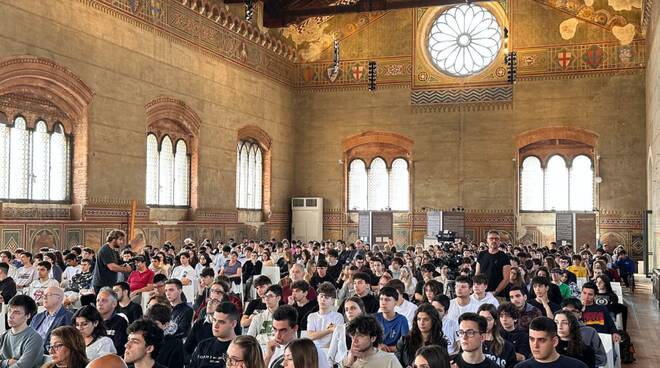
[236, 125, 271, 214]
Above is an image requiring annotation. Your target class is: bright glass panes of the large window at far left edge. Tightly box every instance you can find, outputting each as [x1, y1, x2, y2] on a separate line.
[0, 116, 70, 201]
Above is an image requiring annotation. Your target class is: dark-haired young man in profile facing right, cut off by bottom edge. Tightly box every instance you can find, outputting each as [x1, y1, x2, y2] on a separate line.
[124, 319, 165, 368]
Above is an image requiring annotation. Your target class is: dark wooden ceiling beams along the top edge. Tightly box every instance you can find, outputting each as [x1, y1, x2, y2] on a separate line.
[225, 0, 462, 28]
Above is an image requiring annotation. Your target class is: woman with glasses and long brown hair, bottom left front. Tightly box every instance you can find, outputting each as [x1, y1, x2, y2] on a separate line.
[42, 326, 89, 368]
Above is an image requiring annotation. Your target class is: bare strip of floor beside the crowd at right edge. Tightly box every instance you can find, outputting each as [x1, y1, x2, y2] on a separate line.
[622, 275, 660, 368]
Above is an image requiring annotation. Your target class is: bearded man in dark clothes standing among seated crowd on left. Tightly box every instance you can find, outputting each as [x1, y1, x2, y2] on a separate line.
[92, 230, 133, 294]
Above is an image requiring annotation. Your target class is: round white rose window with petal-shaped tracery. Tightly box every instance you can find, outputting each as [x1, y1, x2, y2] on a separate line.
[428, 4, 502, 77]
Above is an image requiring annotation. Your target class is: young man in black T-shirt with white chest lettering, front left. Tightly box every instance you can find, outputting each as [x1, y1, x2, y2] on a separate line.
[187, 302, 240, 368]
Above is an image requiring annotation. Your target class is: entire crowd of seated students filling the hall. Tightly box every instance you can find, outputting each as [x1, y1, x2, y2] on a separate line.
[0, 230, 634, 368]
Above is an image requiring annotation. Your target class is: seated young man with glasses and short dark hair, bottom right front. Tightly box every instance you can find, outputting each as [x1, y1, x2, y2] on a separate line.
[453, 312, 499, 368]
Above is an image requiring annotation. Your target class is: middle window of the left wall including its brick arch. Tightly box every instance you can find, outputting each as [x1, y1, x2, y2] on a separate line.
[145, 97, 201, 208]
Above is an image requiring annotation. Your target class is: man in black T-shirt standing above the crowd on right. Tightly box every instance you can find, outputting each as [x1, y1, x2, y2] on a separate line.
[475, 230, 511, 296]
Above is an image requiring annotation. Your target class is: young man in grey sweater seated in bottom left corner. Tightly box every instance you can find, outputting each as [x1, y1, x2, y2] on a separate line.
[0, 295, 44, 367]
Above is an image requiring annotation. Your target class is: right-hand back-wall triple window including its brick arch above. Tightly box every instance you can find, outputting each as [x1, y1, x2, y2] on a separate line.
[517, 127, 598, 211]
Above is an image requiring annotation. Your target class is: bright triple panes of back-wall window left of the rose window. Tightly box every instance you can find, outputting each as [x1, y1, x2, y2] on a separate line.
[348, 157, 410, 211]
